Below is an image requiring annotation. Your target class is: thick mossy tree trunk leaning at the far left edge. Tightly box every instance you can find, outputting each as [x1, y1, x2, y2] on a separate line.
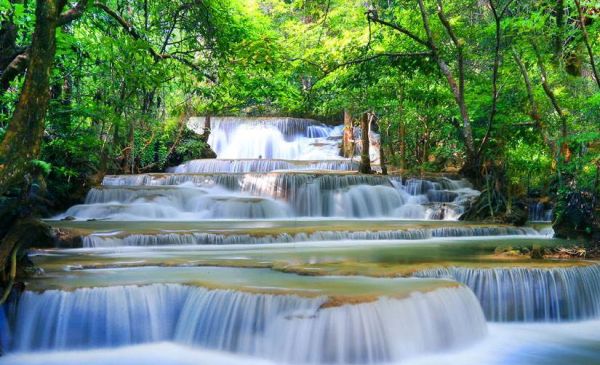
[0, 0, 63, 195]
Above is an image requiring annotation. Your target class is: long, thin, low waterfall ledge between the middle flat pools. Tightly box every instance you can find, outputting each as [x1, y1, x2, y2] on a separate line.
[82, 226, 542, 248]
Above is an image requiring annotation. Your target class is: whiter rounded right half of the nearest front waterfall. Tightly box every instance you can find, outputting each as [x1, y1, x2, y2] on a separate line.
[258, 288, 487, 364]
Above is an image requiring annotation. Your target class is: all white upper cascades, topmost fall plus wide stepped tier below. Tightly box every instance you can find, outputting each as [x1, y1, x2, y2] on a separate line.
[52, 117, 479, 220]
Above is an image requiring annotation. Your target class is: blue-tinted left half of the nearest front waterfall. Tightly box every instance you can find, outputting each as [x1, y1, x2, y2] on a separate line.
[13, 284, 324, 351]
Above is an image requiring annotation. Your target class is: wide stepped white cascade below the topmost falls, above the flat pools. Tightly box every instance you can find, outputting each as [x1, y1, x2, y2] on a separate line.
[58, 173, 479, 220]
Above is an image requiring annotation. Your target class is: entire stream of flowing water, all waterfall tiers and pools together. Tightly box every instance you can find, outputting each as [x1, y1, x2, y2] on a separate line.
[0, 118, 600, 364]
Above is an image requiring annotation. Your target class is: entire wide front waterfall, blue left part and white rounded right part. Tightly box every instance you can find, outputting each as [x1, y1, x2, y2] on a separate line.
[12, 284, 487, 364]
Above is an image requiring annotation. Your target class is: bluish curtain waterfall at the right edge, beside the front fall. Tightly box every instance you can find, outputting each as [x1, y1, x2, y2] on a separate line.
[415, 265, 600, 322]
